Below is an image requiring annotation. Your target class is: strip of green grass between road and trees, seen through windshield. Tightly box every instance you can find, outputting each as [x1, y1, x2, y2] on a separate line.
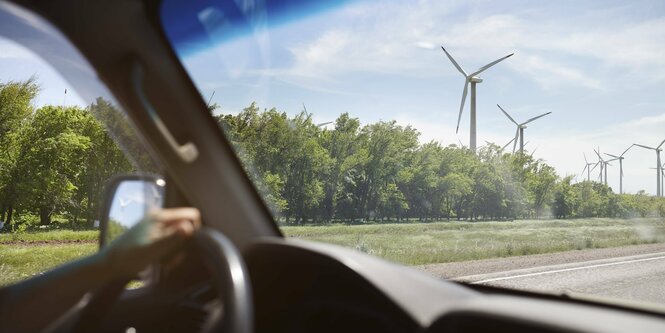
[282, 219, 665, 265]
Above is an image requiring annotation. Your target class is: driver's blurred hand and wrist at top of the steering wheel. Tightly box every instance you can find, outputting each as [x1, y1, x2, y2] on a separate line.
[99, 208, 201, 278]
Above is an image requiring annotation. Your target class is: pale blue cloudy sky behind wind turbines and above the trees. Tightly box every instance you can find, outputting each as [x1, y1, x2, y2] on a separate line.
[0, 0, 665, 194]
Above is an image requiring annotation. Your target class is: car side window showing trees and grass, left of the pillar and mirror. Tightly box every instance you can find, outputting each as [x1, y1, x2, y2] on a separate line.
[0, 31, 159, 286]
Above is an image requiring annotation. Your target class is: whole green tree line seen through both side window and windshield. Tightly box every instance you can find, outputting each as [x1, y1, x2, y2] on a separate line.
[0, 78, 665, 230]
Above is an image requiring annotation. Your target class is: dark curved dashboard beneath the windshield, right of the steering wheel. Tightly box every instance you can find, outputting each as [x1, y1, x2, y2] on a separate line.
[245, 239, 665, 333]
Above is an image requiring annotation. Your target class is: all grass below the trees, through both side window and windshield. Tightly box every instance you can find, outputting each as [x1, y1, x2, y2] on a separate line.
[0, 218, 665, 285]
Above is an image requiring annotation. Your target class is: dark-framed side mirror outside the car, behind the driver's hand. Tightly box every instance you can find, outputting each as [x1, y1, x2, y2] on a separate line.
[99, 174, 166, 249]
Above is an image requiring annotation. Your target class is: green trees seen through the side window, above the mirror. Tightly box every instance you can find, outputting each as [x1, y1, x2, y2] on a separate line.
[0, 78, 144, 230]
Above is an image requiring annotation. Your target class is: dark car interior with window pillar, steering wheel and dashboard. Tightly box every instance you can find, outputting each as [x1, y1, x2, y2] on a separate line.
[0, 0, 665, 333]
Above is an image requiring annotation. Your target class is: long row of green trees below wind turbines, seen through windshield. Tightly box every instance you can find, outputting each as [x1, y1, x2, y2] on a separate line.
[216, 104, 665, 223]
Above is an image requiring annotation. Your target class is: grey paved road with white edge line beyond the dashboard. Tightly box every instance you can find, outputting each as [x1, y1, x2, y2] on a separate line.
[422, 246, 665, 304]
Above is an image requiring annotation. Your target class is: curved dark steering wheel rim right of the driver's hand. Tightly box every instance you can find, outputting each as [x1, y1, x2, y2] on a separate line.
[194, 227, 254, 333]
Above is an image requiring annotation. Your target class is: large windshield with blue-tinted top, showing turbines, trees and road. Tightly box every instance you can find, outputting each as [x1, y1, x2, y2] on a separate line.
[160, 0, 665, 303]
